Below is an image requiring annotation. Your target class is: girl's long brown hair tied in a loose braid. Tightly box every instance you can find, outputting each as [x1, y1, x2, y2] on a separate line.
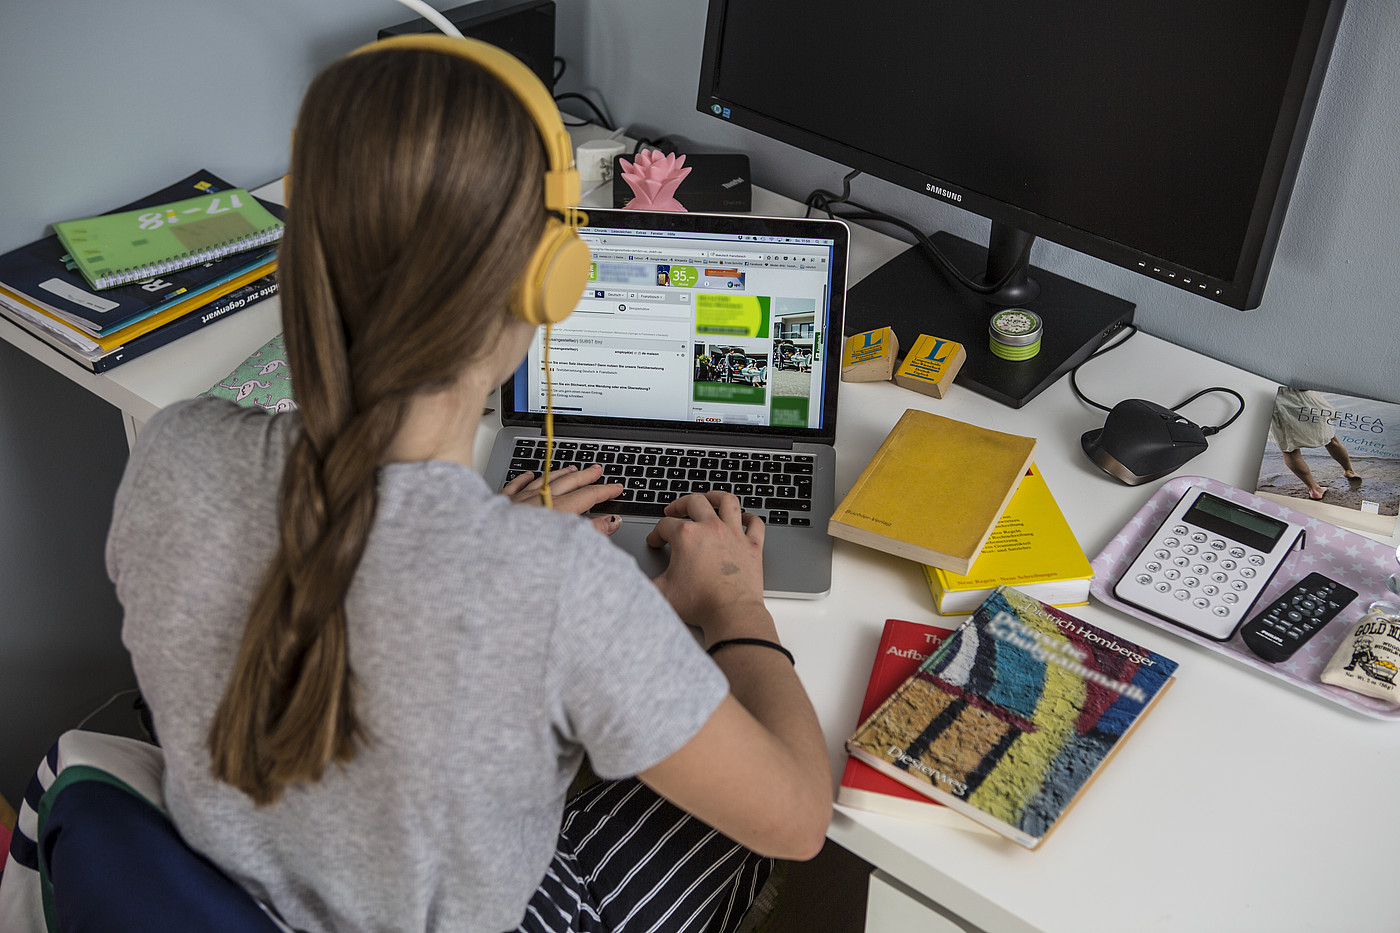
[209, 50, 545, 804]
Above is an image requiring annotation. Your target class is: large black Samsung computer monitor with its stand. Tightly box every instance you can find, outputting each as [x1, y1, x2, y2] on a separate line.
[697, 0, 1344, 408]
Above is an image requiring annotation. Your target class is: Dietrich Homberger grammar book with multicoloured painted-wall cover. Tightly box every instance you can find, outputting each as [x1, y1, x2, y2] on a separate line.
[847, 587, 1177, 849]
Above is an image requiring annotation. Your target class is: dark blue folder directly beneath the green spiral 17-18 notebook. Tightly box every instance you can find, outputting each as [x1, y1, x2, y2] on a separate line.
[0, 171, 284, 336]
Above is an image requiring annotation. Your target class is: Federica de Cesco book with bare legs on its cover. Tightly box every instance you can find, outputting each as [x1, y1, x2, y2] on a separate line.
[1254, 385, 1400, 535]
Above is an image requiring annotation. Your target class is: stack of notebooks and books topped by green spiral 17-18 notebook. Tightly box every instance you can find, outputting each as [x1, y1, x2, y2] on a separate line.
[0, 171, 283, 373]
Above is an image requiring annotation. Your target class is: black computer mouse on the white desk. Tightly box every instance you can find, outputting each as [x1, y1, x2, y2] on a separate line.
[1079, 398, 1207, 486]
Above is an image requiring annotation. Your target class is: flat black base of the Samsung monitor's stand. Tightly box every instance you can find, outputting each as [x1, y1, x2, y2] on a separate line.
[846, 233, 1137, 408]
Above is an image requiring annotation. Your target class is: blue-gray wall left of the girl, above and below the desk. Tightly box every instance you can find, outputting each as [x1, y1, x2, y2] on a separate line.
[0, 0, 412, 806]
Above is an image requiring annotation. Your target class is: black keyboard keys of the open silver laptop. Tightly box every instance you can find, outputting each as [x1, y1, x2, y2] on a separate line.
[505, 437, 816, 525]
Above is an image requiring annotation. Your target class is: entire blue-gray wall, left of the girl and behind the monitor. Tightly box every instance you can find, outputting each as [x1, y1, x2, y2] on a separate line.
[0, 0, 1400, 801]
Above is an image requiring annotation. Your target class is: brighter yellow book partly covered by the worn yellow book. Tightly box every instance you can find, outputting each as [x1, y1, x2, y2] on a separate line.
[924, 464, 1093, 615]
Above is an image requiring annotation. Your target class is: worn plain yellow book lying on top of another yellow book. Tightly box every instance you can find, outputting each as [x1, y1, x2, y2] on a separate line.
[826, 408, 1036, 573]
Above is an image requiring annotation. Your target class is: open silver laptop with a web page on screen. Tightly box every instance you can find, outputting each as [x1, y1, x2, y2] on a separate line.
[484, 210, 847, 598]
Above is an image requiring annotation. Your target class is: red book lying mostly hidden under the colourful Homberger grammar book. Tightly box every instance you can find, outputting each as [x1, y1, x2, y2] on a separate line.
[836, 619, 991, 834]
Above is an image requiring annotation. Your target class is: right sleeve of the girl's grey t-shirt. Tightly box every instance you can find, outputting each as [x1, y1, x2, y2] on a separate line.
[549, 528, 729, 779]
